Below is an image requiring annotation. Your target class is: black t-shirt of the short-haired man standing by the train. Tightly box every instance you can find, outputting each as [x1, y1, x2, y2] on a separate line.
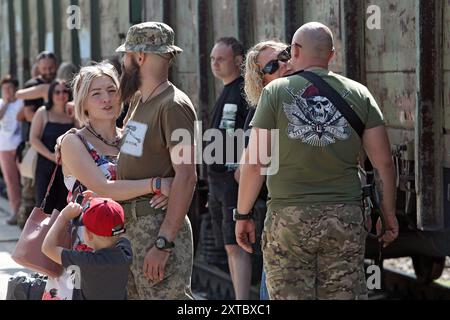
[208, 77, 248, 172]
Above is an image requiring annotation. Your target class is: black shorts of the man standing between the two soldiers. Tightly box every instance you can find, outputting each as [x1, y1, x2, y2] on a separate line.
[208, 171, 238, 247]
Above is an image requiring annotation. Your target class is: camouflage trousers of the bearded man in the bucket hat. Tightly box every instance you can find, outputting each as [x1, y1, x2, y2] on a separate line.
[123, 200, 194, 300]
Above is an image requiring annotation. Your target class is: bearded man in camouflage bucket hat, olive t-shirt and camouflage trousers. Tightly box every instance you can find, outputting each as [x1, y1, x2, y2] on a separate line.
[117, 22, 196, 300]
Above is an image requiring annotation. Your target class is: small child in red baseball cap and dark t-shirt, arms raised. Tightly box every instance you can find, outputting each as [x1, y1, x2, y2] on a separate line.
[42, 198, 132, 300]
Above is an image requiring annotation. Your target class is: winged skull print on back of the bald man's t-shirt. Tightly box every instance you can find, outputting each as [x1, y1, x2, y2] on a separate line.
[283, 85, 351, 147]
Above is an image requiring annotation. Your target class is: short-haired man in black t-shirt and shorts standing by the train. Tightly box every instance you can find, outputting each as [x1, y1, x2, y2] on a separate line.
[208, 38, 252, 300]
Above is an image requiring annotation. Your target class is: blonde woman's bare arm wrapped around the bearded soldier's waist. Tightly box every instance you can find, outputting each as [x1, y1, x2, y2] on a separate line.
[61, 134, 171, 201]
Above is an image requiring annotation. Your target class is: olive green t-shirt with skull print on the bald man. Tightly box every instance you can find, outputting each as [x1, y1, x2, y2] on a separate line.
[252, 69, 384, 209]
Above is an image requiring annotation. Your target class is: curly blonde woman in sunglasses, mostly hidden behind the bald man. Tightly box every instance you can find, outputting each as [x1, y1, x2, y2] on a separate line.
[239, 41, 292, 300]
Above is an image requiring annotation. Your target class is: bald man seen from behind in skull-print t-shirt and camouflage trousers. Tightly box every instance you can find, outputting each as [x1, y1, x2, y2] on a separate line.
[235, 22, 398, 299]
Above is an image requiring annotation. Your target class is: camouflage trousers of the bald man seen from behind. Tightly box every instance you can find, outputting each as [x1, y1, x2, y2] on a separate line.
[262, 204, 367, 300]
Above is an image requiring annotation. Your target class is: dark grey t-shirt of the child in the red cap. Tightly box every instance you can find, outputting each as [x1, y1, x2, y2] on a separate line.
[61, 238, 133, 300]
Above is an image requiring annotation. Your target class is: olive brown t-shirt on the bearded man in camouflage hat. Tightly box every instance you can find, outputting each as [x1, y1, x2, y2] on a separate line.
[117, 85, 196, 195]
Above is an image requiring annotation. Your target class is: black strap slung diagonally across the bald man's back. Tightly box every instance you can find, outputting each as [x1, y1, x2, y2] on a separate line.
[295, 70, 365, 139]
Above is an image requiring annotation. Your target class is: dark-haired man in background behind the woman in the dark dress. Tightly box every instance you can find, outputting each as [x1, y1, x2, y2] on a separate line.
[17, 51, 58, 227]
